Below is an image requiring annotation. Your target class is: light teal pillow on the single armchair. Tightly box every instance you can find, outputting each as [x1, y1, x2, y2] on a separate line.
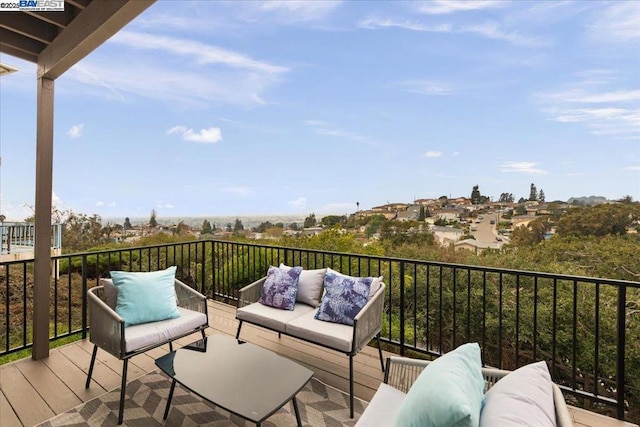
[110, 266, 180, 327]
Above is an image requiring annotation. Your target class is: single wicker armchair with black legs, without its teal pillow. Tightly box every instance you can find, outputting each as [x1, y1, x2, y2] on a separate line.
[85, 279, 209, 424]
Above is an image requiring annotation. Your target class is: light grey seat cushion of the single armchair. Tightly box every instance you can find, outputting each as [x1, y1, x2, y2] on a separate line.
[124, 307, 207, 353]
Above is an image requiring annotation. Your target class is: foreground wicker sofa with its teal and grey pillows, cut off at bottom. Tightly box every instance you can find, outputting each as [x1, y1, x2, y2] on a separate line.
[356, 343, 573, 427]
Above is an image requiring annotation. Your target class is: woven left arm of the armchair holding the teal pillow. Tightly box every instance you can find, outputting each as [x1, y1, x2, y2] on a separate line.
[87, 286, 125, 359]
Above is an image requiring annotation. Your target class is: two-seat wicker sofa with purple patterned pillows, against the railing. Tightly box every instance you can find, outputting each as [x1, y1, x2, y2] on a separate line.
[236, 264, 386, 418]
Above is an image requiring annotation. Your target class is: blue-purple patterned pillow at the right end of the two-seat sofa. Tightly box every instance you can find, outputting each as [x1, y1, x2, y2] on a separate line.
[315, 268, 374, 325]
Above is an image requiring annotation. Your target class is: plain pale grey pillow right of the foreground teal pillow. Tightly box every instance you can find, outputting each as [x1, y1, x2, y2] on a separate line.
[480, 362, 556, 427]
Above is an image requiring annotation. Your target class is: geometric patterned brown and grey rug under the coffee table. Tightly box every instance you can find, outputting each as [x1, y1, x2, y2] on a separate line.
[40, 372, 367, 427]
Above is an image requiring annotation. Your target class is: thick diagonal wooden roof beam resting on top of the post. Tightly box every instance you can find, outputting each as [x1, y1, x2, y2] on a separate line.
[38, 0, 155, 79]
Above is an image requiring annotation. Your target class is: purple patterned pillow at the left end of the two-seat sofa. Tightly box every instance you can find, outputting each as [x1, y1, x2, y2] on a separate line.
[258, 266, 302, 310]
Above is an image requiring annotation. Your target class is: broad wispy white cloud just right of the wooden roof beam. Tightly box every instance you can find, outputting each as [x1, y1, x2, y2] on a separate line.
[63, 31, 288, 108]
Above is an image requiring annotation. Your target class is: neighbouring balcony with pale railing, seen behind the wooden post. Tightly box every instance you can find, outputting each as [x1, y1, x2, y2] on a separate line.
[0, 222, 62, 262]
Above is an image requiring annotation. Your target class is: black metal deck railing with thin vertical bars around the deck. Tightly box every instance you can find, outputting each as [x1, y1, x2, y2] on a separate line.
[0, 240, 640, 422]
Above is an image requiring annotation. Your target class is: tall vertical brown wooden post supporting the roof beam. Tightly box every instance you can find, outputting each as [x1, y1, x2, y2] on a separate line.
[31, 78, 54, 360]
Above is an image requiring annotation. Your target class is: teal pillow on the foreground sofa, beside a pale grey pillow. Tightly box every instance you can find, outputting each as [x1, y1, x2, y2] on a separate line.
[396, 343, 484, 427]
